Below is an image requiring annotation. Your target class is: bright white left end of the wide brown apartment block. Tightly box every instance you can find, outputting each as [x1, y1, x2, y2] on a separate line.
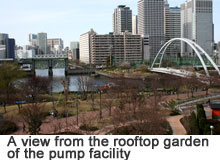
[79, 29, 95, 64]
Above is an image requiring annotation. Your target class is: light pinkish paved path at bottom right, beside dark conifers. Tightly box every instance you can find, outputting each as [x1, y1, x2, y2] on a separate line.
[167, 115, 187, 135]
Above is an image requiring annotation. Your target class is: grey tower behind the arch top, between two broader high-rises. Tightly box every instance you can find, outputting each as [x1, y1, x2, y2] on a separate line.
[164, 0, 181, 57]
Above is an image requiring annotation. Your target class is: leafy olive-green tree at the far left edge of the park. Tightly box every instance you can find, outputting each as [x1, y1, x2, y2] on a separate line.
[0, 63, 25, 113]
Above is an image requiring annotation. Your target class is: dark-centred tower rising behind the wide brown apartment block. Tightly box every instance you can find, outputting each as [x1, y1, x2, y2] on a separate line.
[112, 5, 132, 34]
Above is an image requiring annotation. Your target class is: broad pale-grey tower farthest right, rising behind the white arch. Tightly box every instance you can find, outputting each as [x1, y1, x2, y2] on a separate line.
[181, 0, 214, 56]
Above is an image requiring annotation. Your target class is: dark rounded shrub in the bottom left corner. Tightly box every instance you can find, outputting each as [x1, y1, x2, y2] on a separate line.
[0, 121, 18, 135]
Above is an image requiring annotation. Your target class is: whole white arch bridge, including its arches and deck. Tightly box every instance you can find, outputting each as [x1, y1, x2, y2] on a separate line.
[150, 38, 220, 77]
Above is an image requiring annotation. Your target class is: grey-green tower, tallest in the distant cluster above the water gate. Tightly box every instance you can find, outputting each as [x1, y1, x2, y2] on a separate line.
[37, 33, 48, 54]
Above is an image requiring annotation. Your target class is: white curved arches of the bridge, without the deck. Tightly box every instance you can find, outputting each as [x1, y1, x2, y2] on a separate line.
[151, 38, 220, 76]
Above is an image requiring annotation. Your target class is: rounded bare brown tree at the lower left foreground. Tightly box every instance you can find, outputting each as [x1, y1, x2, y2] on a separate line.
[21, 103, 45, 135]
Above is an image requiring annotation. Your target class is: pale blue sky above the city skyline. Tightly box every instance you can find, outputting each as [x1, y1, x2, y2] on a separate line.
[0, 0, 220, 46]
